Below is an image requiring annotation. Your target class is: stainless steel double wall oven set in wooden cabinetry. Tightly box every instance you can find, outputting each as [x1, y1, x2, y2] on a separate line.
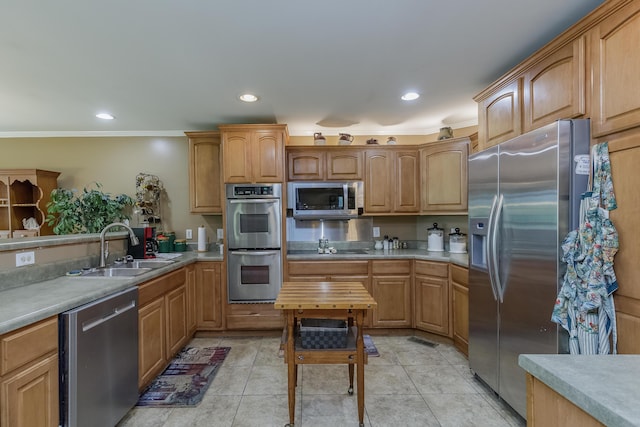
[226, 184, 282, 303]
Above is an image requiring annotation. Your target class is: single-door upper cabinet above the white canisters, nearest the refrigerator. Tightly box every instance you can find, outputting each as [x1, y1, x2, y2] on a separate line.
[420, 138, 469, 214]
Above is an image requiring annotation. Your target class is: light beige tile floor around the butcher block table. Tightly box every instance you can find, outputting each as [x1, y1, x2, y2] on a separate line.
[118, 336, 525, 427]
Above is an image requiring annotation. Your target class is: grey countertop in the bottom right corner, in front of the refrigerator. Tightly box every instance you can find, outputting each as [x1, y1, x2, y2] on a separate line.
[518, 354, 640, 427]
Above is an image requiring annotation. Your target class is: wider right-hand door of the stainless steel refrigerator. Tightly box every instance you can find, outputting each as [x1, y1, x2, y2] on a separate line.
[497, 122, 570, 416]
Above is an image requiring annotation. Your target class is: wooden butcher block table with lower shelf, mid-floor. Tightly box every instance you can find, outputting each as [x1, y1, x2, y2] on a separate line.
[275, 282, 377, 426]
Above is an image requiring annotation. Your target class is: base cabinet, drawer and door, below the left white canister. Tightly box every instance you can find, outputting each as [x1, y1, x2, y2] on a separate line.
[414, 260, 450, 336]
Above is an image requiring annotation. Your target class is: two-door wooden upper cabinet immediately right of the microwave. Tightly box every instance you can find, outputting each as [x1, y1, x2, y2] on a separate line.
[364, 148, 420, 214]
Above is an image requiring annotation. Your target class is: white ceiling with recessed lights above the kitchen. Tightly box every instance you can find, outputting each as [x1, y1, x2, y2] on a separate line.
[0, 0, 602, 137]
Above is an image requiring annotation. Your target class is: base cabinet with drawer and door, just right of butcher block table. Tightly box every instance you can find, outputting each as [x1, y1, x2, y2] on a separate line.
[371, 260, 412, 328]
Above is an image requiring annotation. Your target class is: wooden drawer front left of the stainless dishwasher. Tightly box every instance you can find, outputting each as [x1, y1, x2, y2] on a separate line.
[0, 317, 58, 375]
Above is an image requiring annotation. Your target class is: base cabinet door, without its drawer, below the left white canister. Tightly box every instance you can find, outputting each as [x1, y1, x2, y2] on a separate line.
[415, 276, 449, 335]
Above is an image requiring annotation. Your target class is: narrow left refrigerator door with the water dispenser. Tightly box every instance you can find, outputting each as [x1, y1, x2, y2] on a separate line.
[469, 147, 498, 391]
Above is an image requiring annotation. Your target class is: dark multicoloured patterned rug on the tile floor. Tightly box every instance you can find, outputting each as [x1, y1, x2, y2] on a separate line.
[137, 347, 231, 407]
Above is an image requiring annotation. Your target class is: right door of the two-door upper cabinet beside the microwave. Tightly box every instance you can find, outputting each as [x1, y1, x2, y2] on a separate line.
[393, 150, 420, 212]
